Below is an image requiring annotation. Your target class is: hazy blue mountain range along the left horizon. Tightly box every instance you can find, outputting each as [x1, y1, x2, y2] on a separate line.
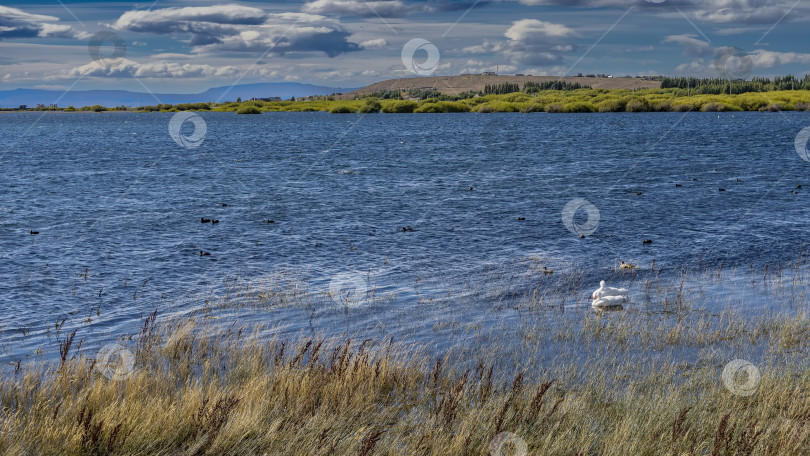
[0, 82, 354, 108]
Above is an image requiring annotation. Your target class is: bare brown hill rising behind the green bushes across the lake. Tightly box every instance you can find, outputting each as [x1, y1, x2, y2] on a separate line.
[344, 74, 661, 98]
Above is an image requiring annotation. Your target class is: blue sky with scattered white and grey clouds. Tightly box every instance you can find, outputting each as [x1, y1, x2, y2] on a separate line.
[0, 0, 810, 93]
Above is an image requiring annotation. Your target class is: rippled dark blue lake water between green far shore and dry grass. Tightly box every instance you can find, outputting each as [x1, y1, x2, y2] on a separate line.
[0, 112, 810, 366]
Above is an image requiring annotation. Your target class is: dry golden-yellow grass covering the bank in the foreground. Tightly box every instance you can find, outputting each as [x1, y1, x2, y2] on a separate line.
[0, 308, 810, 455]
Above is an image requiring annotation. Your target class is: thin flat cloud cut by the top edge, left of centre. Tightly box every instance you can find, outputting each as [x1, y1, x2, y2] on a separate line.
[301, 0, 480, 17]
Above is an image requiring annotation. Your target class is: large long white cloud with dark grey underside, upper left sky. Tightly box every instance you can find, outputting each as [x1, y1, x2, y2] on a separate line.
[112, 4, 361, 57]
